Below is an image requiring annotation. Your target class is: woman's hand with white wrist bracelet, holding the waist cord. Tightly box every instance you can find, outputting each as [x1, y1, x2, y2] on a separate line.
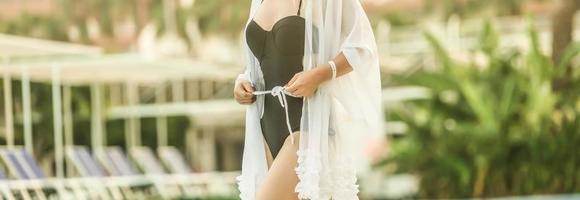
[284, 65, 332, 97]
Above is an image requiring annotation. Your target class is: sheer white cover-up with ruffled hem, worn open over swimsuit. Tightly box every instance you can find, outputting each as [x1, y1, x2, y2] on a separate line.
[237, 0, 383, 200]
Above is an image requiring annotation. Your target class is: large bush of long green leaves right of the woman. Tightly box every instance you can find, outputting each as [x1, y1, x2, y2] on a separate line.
[382, 19, 580, 198]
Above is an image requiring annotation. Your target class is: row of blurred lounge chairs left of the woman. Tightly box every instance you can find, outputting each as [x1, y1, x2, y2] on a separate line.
[0, 146, 238, 200]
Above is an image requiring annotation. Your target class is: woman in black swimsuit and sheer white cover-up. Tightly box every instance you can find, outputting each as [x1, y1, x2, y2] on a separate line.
[234, 0, 382, 200]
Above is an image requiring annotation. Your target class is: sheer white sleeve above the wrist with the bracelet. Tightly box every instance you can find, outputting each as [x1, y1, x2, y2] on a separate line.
[334, 0, 383, 134]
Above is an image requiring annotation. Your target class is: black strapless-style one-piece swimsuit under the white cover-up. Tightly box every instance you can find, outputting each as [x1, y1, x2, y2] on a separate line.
[246, 1, 305, 157]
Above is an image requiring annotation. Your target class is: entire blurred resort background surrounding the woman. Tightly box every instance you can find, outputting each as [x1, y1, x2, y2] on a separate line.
[0, 0, 580, 199]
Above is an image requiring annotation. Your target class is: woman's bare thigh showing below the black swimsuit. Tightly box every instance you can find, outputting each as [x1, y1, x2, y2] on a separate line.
[257, 132, 300, 200]
